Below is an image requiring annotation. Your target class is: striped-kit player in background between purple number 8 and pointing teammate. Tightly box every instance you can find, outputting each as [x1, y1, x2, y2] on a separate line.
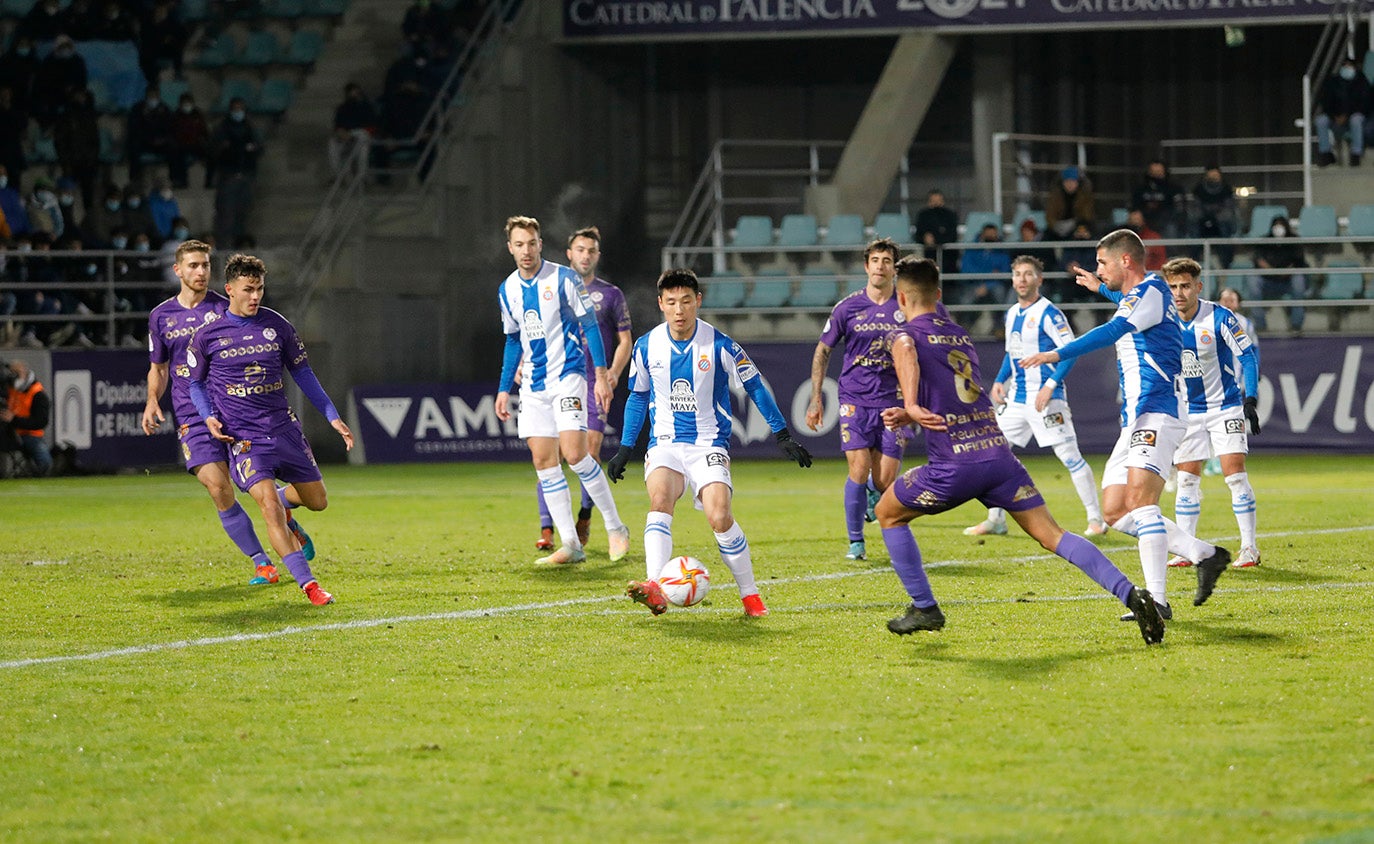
[963, 254, 1107, 536]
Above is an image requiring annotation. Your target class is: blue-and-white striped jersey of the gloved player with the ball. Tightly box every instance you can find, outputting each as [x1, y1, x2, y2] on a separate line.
[629, 319, 786, 448]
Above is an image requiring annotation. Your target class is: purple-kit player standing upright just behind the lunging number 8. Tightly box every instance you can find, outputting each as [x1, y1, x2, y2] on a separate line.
[807, 238, 910, 559]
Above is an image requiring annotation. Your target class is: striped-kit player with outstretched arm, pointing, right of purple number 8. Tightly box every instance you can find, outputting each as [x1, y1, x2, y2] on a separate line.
[1021, 228, 1231, 620]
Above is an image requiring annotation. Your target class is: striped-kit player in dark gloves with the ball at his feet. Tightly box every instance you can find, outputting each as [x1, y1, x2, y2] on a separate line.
[606, 269, 811, 617]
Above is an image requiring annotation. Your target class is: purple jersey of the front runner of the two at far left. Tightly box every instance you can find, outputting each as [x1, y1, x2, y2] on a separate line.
[187, 308, 306, 440]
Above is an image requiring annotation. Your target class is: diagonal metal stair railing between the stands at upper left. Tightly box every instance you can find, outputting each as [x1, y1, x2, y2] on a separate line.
[291, 0, 521, 313]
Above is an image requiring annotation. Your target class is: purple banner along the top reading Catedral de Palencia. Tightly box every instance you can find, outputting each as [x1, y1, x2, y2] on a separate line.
[563, 0, 1333, 38]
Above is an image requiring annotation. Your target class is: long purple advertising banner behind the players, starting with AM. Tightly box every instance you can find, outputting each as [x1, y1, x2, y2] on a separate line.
[350, 337, 1374, 463]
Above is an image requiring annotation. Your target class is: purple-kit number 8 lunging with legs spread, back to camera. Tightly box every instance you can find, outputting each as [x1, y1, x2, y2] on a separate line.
[878, 257, 1164, 645]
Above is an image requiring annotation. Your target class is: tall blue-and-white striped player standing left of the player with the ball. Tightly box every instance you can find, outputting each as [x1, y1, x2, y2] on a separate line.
[496, 217, 629, 565]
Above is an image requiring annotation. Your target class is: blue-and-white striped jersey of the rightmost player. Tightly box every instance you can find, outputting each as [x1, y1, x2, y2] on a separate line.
[1180, 300, 1254, 414]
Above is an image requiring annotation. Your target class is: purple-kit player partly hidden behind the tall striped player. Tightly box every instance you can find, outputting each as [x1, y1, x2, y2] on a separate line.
[534, 225, 635, 551]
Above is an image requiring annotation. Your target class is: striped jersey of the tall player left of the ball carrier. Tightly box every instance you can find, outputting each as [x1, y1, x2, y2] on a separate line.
[497, 261, 594, 392]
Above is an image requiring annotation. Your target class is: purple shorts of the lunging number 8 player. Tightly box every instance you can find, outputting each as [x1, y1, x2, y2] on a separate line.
[892, 458, 1044, 514]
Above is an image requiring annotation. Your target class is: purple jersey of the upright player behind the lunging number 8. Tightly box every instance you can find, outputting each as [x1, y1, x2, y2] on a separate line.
[820, 290, 904, 407]
